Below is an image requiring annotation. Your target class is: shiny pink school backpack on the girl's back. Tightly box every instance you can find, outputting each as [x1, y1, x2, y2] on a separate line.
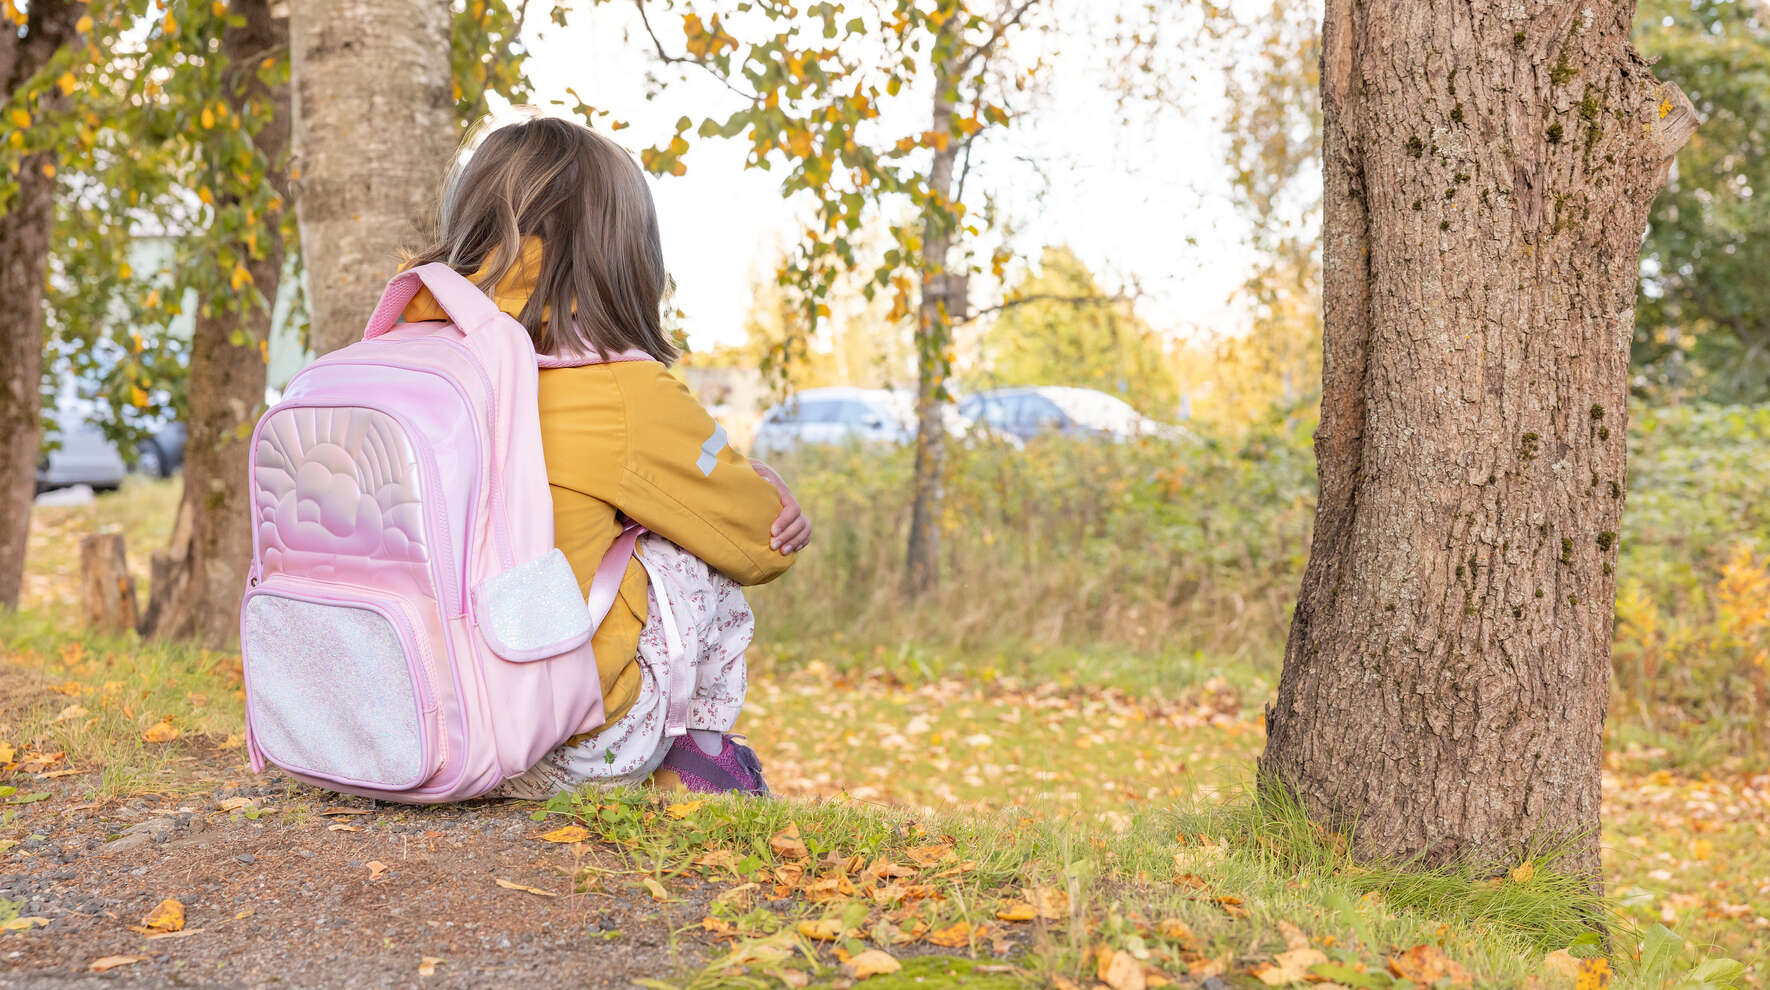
[241, 264, 644, 802]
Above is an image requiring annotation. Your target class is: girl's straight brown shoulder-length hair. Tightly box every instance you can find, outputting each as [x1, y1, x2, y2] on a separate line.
[409, 115, 681, 365]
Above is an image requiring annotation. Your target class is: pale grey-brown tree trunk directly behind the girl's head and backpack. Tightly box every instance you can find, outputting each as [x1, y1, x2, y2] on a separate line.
[290, 0, 457, 354]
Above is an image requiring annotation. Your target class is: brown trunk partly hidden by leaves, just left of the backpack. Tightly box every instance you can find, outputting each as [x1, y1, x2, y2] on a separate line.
[142, 0, 289, 646]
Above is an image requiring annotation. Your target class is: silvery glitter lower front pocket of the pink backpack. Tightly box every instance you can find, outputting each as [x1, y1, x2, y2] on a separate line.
[241, 577, 444, 790]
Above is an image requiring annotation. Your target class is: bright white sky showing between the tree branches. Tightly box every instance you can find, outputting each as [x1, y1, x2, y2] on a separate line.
[526, 4, 1251, 349]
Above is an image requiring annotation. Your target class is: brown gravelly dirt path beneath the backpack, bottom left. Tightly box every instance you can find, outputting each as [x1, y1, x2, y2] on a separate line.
[0, 776, 710, 988]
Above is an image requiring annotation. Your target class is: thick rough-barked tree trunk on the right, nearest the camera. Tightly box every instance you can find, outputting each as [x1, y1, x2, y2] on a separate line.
[1260, 0, 1696, 880]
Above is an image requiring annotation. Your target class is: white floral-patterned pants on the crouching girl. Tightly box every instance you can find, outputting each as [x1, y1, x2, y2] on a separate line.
[487, 533, 756, 801]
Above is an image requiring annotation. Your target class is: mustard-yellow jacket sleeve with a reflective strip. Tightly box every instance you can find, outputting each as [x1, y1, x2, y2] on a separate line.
[616, 363, 793, 584]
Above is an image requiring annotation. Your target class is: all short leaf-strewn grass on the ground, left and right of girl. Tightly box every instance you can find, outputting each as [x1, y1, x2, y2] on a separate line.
[0, 485, 1770, 986]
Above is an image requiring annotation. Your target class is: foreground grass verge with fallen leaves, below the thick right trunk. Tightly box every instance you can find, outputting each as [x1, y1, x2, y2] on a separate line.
[531, 792, 1677, 986]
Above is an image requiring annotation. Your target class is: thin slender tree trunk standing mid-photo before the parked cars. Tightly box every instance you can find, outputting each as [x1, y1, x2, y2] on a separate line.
[904, 36, 959, 597]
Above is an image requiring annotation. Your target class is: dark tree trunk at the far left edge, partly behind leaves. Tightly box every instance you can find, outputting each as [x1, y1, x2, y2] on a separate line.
[0, 0, 87, 607]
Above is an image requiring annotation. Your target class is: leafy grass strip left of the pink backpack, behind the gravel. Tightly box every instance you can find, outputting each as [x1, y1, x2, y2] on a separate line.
[0, 611, 244, 799]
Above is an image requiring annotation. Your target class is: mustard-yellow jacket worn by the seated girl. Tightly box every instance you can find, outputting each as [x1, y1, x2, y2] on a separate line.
[405, 247, 793, 723]
